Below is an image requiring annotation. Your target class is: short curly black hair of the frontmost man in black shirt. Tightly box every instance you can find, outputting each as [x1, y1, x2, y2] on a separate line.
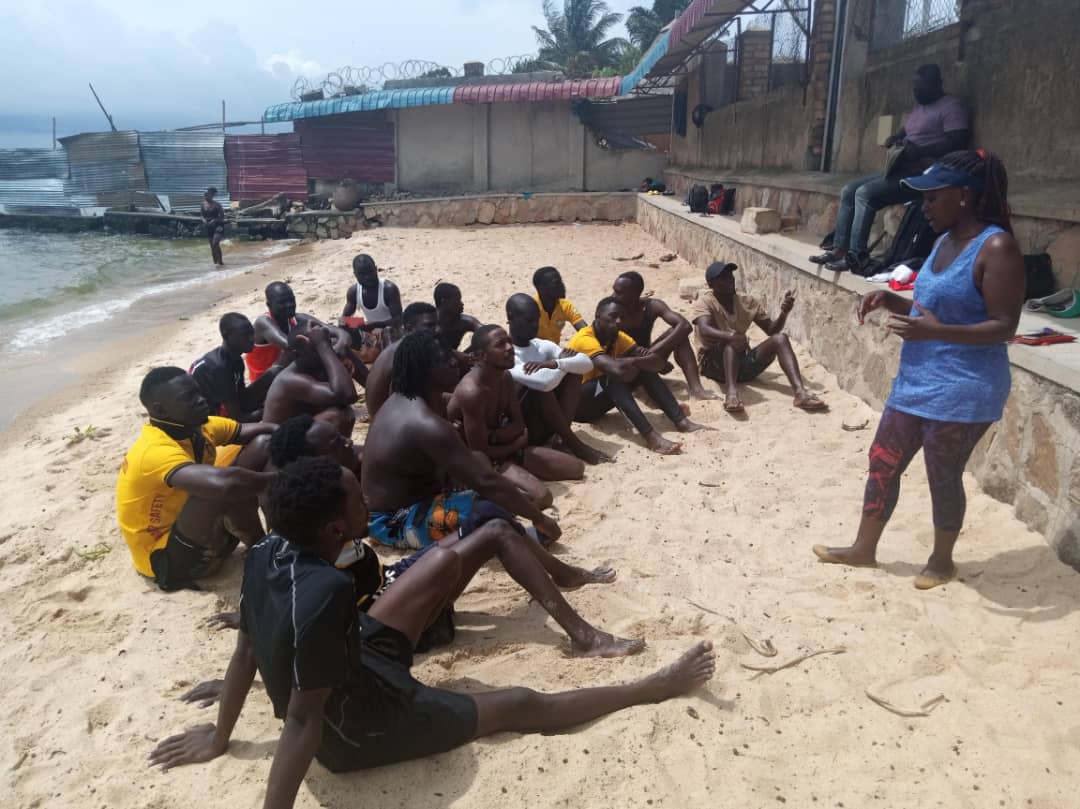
[267, 457, 346, 548]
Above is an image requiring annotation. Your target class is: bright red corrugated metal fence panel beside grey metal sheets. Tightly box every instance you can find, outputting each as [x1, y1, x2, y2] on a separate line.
[225, 133, 308, 200]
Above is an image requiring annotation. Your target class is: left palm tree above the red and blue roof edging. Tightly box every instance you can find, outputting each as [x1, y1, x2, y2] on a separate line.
[532, 0, 626, 79]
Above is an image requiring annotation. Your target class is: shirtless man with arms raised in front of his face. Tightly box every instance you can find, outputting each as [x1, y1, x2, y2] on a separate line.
[262, 324, 357, 424]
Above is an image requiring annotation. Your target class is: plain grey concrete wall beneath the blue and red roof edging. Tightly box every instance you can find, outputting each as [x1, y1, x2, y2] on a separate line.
[397, 102, 667, 194]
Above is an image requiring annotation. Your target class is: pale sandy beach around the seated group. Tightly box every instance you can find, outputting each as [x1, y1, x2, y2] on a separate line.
[0, 225, 1080, 809]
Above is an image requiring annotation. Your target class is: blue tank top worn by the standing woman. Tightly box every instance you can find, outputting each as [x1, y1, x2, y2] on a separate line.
[886, 225, 1012, 423]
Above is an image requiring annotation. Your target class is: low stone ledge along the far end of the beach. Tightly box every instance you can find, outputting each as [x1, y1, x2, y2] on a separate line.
[363, 192, 637, 228]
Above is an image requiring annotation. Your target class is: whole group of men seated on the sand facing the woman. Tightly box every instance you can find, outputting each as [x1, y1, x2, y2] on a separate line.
[117, 255, 825, 806]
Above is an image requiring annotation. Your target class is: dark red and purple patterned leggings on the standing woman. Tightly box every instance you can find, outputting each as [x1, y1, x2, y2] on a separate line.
[863, 407, 990, 531]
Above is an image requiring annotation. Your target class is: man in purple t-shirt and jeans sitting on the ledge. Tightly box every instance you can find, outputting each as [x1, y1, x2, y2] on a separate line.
[810, 65, 971, 272]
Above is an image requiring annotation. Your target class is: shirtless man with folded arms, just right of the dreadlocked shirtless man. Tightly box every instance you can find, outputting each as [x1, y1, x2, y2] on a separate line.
[446, 325, 585, 509]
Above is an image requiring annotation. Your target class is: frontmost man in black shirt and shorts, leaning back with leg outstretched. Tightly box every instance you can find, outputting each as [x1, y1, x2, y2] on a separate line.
[150, 458, 715, 808]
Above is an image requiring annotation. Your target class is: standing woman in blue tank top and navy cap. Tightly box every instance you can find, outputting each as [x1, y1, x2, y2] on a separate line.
[813, 149, 1025, 590]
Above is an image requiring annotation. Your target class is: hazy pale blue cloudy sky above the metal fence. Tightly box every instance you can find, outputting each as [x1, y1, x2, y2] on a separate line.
[0, 0, 643, 146]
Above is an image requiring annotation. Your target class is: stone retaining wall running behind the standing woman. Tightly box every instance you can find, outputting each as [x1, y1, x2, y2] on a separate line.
[637, 197, 1080, 569]
